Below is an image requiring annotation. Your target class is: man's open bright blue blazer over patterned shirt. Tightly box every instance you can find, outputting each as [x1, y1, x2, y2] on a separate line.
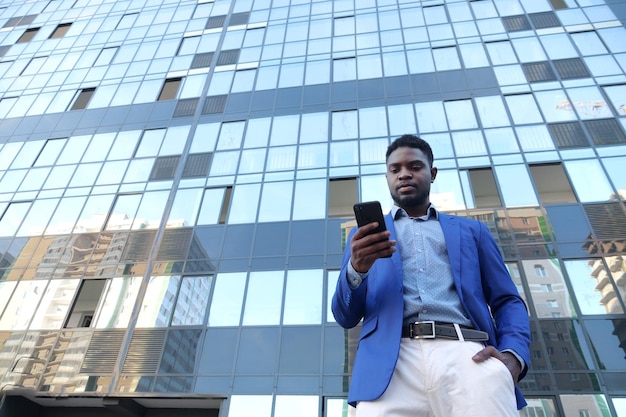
[332, 213, 530, 409]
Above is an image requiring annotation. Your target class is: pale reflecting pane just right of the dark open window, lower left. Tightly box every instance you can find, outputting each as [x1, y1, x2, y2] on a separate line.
[94, 277, 141, 329]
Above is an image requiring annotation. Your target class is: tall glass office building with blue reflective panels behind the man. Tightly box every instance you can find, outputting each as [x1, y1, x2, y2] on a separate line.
[0, 0, 626, 417]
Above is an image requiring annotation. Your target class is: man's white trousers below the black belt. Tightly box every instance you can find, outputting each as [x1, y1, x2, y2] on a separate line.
[356, 338, 519, 417]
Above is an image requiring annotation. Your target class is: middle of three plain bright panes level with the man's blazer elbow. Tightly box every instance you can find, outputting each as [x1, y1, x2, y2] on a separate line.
[243, 271, 285, 326]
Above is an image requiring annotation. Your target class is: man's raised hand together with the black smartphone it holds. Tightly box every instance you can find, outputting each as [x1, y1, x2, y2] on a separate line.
[350, 201, 396, 273]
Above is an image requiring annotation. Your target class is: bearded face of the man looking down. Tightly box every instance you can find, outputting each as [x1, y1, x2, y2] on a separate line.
[386, 147, 437, 216]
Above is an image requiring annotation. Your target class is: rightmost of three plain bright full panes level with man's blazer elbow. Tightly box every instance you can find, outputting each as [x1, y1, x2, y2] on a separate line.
[283, 269, 323, 324]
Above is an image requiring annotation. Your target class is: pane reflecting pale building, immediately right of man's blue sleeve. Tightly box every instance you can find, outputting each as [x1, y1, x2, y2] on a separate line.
[522, 259, 576, 318]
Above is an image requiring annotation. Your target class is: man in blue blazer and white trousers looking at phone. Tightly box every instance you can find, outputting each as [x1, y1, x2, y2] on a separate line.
[332, 135, 530, 417]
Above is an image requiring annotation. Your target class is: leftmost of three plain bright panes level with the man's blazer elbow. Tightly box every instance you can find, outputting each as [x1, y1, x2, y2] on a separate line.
[208, 272, 246, 327]
